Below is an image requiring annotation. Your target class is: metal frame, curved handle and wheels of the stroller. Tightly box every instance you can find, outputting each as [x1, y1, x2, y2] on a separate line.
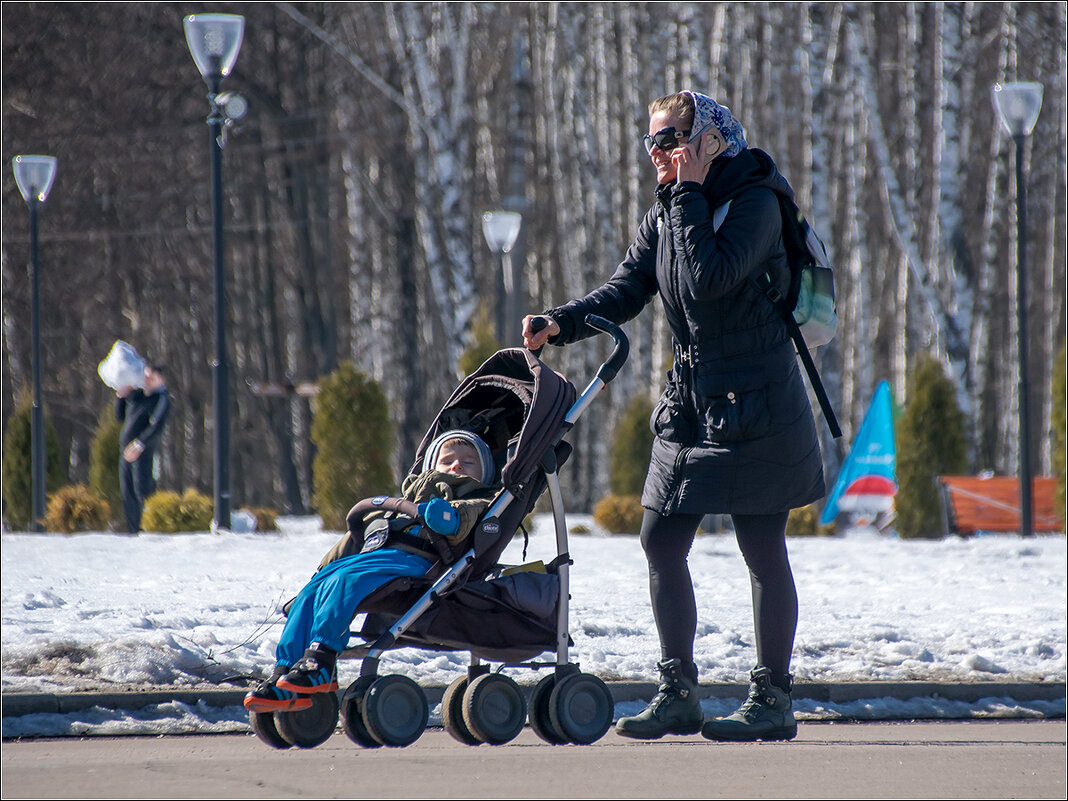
[250, 315, 629, 748]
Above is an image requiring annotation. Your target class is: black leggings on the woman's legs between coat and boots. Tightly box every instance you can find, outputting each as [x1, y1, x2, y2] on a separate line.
[641, 509, 798, 675]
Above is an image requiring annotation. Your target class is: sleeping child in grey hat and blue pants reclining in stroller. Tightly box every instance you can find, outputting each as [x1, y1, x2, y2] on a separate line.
[245, 429, 497, 712]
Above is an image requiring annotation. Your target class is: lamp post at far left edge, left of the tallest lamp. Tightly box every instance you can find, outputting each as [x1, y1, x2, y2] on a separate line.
[12, 156, 56, 531]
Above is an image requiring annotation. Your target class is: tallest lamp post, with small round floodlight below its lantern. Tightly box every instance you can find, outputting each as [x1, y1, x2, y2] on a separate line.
[185, 14, 248, 531]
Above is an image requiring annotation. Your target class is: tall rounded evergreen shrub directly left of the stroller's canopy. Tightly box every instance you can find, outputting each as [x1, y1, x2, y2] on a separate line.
[312, 363, 396, 531]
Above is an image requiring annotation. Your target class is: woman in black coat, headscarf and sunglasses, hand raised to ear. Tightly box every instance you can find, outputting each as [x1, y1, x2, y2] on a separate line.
[523, 92, 824, 740]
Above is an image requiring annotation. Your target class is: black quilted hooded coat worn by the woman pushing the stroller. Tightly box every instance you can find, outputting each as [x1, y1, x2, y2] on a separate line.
[548, 150, 824, 515]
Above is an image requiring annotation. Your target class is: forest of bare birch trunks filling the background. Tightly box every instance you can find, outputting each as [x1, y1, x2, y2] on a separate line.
[0, 2, 1066, 512]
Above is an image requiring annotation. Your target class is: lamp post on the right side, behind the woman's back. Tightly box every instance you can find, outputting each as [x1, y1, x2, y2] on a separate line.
[993, 82, 1042, 537]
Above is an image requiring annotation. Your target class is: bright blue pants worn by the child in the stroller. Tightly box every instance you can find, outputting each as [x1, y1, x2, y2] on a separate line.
[274, 548, 431, 665]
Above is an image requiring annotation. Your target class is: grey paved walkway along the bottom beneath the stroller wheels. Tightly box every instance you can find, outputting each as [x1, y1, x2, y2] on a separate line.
[2, 721, 1066, 799]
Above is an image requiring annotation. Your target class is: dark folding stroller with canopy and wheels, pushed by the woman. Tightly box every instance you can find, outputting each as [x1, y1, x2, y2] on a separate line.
[249, 315, 629, 749]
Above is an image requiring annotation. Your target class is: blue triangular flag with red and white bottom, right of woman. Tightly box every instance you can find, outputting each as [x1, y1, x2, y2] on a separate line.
[819, 381, 897, 525]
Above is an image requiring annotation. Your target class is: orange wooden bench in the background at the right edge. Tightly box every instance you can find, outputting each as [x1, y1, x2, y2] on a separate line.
[938, 475, 1064, 536]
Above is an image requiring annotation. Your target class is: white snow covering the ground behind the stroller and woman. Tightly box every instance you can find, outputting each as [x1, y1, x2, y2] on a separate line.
[0, 516, 1068, 737]
